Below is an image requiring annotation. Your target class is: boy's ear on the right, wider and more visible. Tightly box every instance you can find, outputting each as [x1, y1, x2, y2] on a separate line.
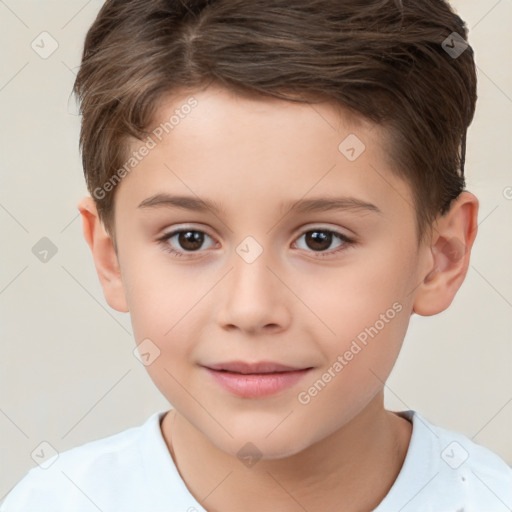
[413, 192, 478, 316]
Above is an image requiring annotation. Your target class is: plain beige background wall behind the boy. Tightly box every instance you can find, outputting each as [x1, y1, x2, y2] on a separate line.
[0, 0, 512, 498]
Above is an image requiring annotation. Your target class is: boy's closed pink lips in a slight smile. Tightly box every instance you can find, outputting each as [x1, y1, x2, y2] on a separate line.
[204, 361, 312, 398]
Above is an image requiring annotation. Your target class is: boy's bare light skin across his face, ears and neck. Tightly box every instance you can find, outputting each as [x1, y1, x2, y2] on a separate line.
[78, 86, 478, 512]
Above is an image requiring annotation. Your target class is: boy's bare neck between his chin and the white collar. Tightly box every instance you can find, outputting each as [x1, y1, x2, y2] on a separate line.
[162, 393, 412, 512]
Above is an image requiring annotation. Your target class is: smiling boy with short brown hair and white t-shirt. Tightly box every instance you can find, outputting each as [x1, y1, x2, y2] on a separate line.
[1, 0, 512, 512]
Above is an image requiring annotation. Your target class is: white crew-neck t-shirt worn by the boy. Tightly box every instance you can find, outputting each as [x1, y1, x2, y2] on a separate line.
[0, 410, 512, 512]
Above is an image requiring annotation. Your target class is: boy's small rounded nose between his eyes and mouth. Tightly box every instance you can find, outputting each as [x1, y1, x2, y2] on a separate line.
[218, 247, 293, 335]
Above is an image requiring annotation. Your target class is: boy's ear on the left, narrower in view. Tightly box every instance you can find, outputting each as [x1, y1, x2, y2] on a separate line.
[78, 197, 129, 313]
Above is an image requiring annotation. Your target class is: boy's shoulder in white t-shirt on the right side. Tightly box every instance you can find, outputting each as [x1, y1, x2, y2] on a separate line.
[378, 410, 512, 512]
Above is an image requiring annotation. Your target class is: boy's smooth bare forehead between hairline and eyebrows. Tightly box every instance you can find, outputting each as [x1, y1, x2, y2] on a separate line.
[113, 87, 416, 224]
